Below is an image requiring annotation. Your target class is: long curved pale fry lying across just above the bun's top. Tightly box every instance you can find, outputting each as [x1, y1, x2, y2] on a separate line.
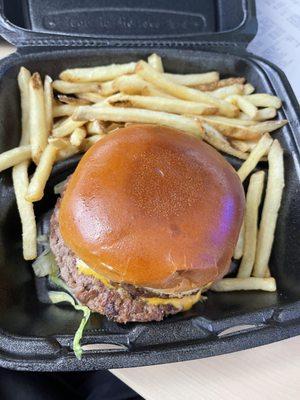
[73, 106, 203, 137]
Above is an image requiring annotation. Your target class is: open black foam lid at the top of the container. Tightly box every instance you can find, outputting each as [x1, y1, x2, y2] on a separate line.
[0, 0, 257, 47]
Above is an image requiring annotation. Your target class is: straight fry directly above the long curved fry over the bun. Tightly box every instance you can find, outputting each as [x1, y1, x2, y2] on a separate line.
[107, 94, 218, 115]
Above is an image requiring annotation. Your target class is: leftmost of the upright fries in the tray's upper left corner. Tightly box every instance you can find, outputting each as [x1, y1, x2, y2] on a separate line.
[18, 67, 31, 146]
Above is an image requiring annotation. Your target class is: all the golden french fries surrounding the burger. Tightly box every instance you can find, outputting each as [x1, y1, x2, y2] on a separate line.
[0, 54, 287, 291]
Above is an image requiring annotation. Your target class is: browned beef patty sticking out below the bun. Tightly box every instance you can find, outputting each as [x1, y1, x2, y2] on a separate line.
[50, 199, 181, 323]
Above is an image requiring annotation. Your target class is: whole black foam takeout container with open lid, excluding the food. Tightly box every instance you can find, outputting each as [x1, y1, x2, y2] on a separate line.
[0, 0, 300, 371]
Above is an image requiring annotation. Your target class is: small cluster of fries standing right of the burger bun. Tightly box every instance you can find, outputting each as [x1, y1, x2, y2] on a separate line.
[211, 133, 284, 292]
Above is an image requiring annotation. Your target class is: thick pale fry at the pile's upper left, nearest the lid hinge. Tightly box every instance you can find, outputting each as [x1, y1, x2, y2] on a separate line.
[59, 62, 136, 82]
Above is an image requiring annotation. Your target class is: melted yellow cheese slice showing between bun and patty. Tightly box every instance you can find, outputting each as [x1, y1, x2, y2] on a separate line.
[76, 259, 201, 311]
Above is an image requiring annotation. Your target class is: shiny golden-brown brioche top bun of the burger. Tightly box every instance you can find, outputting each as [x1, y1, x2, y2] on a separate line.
[59, 125, 245, 293]
